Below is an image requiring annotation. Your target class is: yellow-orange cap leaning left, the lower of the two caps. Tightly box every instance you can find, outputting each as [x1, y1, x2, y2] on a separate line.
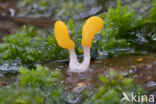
[54, 20, 75, 49]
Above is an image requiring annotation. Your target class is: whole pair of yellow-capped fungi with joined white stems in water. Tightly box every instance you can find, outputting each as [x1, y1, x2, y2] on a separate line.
[54, 16, 104, 72]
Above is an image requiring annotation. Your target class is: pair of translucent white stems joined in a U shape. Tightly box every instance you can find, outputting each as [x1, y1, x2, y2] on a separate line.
[69, 47, 90, 72]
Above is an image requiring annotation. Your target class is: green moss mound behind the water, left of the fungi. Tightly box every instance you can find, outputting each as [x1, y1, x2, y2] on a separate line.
[0, 26, 68, 64]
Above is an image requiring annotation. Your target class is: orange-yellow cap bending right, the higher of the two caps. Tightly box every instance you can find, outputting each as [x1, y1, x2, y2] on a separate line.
[81, 16, 104, 47]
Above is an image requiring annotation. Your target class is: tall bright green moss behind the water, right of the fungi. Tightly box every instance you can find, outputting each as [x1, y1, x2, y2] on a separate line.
[99, 0, 156, 56]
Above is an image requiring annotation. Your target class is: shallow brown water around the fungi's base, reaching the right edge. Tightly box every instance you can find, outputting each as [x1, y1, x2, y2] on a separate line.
[43, 54, 156, 92]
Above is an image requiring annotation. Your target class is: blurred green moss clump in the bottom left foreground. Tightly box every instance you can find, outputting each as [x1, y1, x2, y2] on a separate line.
[0, 65, 71, 104]
